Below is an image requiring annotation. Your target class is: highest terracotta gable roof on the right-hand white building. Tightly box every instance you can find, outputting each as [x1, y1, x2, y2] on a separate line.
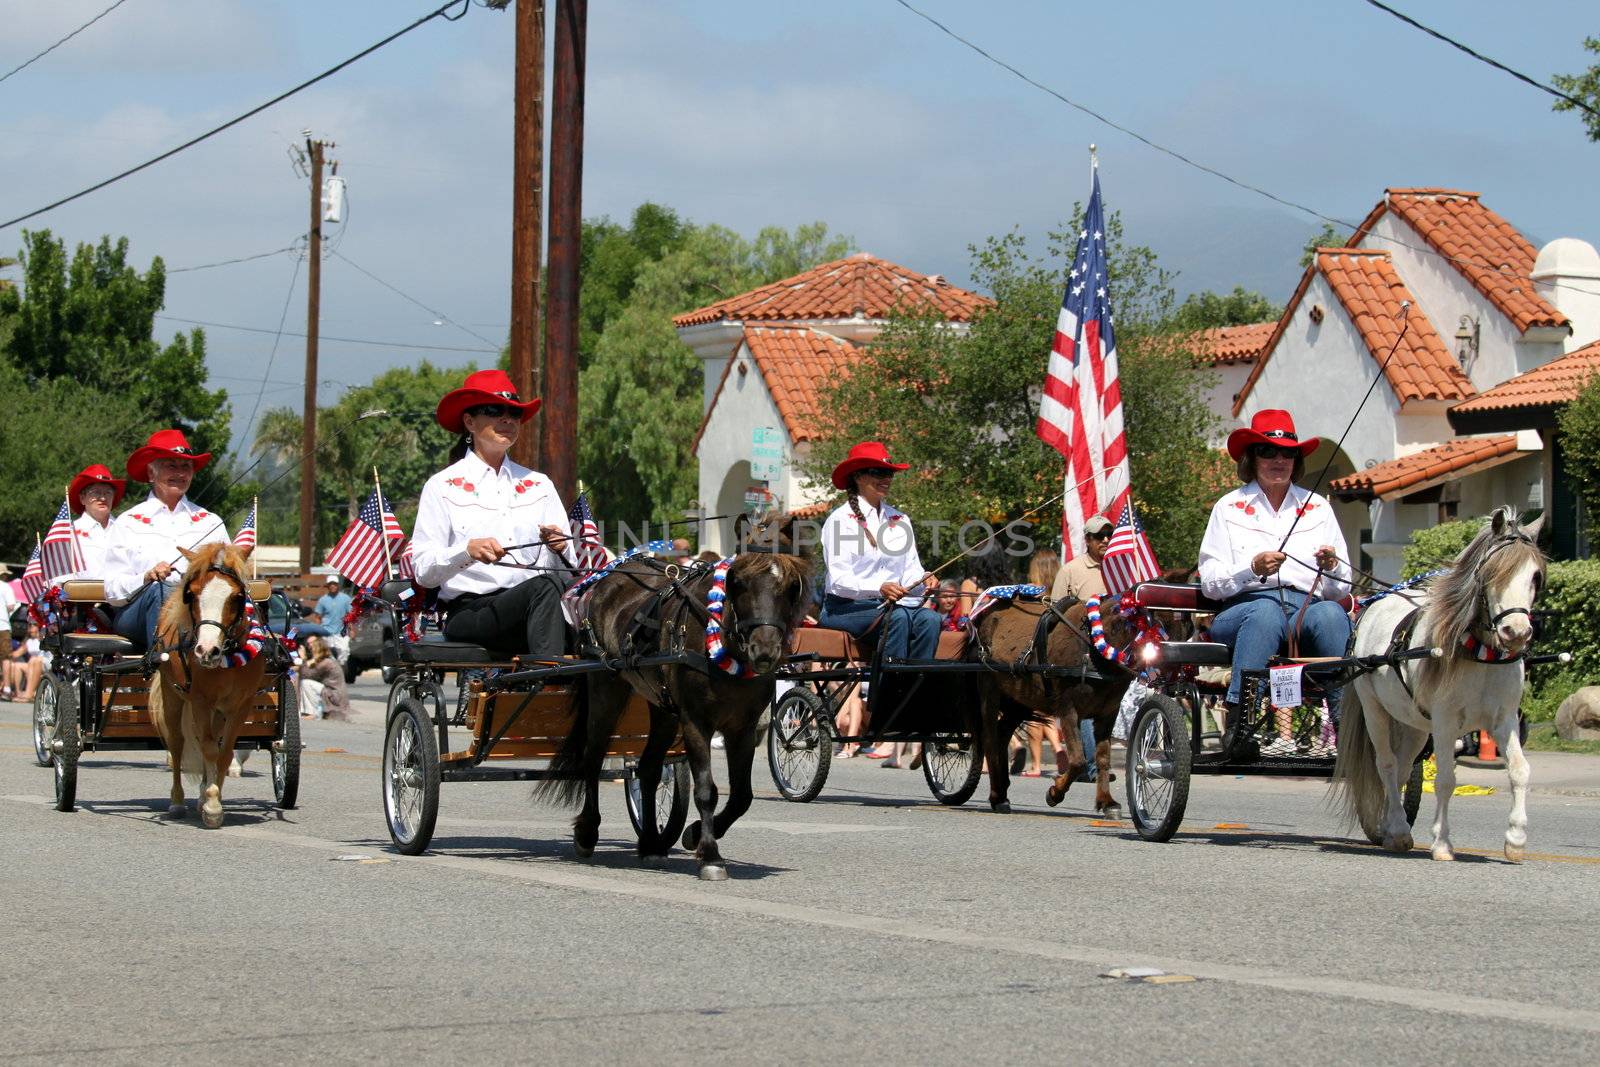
[1349, 189, 1571, 331]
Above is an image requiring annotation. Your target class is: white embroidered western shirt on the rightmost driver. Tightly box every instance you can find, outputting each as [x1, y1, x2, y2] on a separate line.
[1200, 482, 1350, 600]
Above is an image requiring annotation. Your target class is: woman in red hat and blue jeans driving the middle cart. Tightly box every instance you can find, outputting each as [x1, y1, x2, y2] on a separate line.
[818, 442, 941, 726]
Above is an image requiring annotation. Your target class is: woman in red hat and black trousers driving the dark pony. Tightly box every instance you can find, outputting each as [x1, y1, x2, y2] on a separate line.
[411, 371, 571, 659]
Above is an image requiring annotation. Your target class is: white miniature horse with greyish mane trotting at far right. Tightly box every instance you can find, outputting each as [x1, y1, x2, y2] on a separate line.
[1331, 507, 1544, 862]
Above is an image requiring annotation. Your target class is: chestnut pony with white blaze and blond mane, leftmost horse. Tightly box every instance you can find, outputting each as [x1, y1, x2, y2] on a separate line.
[150, 542, 269, 830]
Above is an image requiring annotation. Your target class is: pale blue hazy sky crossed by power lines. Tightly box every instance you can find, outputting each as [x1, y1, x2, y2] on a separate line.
[0, 0, 1600, 454]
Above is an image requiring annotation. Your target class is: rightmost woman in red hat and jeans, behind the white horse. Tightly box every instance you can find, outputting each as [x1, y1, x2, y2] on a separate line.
[1200, 410, 1350, 755]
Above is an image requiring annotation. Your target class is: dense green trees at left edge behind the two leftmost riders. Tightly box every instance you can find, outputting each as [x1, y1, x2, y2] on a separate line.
[0, 230, 237, 560]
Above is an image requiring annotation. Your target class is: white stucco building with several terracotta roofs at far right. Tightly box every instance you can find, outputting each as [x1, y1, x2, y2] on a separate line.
[1218, 189, 1600, 579]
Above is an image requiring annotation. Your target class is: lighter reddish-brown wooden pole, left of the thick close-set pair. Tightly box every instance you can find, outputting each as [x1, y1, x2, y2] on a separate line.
[510, 0, 544, 470]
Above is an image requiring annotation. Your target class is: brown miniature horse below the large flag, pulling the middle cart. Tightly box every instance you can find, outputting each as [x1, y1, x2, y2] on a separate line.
[968, 569, 1190, 814]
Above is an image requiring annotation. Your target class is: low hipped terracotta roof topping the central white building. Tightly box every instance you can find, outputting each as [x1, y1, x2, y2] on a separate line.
[672, 253, 994, 326]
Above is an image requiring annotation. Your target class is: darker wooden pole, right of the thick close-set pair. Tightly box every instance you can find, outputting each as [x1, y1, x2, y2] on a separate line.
[539, 0, 589, 501]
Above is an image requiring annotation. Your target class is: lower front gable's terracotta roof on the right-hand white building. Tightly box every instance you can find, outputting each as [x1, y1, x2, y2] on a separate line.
[1234, 248, 1474, 416]
